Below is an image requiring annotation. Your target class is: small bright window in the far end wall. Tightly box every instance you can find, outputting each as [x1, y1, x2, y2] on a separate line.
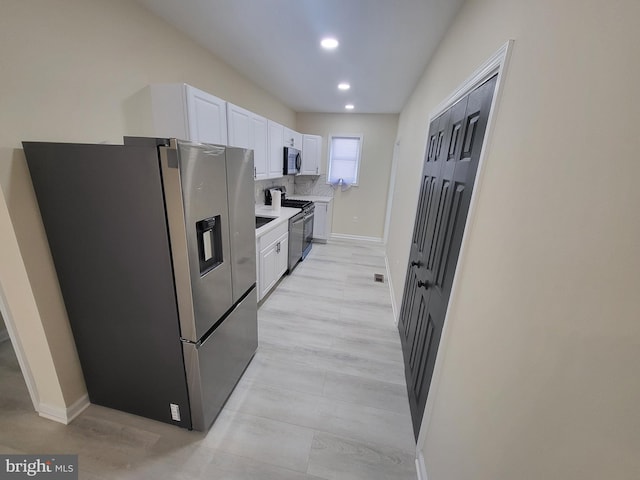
[327, 135, 362, 185]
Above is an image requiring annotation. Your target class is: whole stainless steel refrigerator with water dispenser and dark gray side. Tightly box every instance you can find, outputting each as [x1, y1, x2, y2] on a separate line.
[23, 137, 258, 430]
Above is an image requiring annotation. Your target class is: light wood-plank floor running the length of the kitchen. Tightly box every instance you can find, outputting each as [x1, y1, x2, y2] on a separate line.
[0, 242, 416, 480]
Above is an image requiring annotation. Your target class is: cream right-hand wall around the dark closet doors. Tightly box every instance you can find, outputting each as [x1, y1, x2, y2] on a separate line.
[388, 0, 640, 480]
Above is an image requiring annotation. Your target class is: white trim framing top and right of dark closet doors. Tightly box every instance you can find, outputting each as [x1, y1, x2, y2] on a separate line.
[416, 40, 514, 480]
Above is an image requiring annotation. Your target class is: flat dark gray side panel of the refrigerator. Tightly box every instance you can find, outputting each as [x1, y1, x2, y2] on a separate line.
[24, 142, 191, 427]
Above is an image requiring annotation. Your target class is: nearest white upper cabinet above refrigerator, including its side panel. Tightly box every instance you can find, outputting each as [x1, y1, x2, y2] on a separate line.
[150, 83, 227, 145]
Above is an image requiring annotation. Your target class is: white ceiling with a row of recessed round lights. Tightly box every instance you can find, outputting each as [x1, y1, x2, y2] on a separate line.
[138, 0, 464, 113]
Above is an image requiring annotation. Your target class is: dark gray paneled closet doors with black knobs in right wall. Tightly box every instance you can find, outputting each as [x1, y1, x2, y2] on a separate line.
[398, 77, 496, 438]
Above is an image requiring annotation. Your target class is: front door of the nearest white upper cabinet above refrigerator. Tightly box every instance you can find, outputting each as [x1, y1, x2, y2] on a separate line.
[185, 85, 227, 145]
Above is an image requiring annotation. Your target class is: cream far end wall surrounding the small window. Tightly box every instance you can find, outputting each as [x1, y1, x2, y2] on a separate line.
[296, 113, 398, 239]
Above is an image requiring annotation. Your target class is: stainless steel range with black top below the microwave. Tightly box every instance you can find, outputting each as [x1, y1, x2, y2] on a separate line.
[264, 187, 315, 273]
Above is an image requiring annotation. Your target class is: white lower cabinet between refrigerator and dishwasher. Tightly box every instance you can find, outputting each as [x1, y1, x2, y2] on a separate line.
[256, 222, 289, 300]
